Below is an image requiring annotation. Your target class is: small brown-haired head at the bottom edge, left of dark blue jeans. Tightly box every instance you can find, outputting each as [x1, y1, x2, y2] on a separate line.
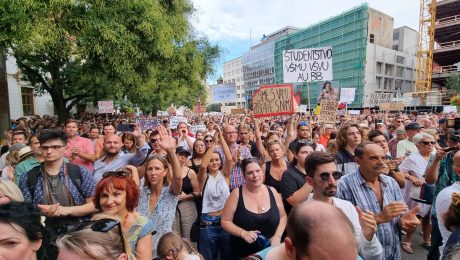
[157, 232, 204, 260]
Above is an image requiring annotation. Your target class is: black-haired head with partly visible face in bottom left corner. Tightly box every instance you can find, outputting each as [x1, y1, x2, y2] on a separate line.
[0, 202, 46, 260]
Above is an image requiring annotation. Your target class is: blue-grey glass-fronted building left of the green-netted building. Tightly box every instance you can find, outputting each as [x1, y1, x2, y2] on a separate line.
[242, 26, 299, 108]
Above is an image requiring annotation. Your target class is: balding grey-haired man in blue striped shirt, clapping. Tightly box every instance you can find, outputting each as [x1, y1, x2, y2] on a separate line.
[337, 142, 420, 260]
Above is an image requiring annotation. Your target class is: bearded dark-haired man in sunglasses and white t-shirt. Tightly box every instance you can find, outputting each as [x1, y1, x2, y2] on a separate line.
[305, 152, 382, 260]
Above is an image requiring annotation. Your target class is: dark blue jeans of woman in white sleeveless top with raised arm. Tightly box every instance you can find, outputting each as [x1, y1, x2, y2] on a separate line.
[199, 214, 231, 260]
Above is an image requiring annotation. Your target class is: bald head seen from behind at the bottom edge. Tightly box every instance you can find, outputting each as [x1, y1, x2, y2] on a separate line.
[285, 201, 358, 259]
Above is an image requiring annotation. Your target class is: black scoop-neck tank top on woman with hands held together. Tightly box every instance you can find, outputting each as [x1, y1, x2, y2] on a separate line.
[230, 186, 280, 259]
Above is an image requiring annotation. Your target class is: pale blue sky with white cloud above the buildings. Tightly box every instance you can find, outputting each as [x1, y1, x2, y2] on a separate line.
[192, 0, 420, 84]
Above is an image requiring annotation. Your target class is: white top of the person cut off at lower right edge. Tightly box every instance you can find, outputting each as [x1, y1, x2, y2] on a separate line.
[436, 181, 460, 259]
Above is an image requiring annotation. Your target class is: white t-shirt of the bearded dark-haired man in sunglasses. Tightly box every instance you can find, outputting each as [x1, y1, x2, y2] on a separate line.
[307, 196, 383, 260]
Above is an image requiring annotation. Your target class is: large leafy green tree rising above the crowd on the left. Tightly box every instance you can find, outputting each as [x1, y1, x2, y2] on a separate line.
[0, 0, 220, 121]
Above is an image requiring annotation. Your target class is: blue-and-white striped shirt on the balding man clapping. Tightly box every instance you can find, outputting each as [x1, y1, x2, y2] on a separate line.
[337, 169, 404, 260]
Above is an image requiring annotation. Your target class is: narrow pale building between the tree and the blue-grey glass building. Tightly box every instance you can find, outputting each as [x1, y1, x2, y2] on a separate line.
[222, 57, 246, 107]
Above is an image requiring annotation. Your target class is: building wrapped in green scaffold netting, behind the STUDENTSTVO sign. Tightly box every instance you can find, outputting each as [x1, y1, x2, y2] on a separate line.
[274, 4, 417, 108]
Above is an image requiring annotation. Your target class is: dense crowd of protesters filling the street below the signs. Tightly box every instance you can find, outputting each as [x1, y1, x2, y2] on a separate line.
[0, 109, 460, 260]
